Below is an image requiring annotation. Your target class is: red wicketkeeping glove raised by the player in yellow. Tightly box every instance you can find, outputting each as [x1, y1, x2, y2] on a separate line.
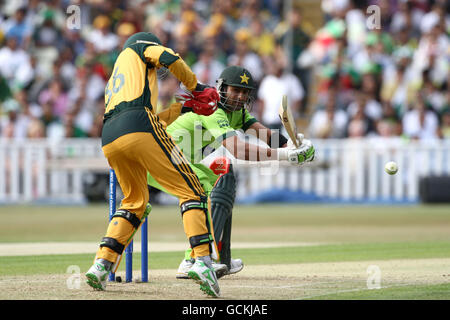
[175, 88, 220, 116]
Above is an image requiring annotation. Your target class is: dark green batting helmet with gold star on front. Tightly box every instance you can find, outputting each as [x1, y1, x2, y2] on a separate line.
[216, 66, 256, 111]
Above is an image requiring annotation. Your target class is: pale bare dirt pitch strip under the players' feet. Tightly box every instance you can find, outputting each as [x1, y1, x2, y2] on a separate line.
[0, 259, 450, 300]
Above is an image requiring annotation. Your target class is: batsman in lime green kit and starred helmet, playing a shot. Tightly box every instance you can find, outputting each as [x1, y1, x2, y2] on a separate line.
[148, 66, 315, 279]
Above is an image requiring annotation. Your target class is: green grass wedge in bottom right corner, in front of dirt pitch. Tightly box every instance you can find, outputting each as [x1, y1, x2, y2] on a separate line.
[306, 283, 450, 300]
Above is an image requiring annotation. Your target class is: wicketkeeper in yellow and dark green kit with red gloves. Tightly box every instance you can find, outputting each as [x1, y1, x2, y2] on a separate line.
[86, 32, 220, 297]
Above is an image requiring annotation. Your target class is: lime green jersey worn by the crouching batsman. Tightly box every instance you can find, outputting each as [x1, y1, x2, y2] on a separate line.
[167, 108, 257, 163]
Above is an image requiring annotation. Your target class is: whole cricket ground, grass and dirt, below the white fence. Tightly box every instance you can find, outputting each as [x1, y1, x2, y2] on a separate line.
[0, 205, 450, 300]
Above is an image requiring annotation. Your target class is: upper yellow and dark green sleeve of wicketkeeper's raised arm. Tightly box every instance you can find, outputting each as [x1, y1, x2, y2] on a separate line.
[144, 46, 197, 91]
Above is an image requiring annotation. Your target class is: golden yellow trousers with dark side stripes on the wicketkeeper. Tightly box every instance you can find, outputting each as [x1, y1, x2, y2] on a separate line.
[96, 108, 210, 269]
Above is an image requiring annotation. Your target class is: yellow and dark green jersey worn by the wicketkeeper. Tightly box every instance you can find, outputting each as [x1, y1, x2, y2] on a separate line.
[102, 43, 197, 145]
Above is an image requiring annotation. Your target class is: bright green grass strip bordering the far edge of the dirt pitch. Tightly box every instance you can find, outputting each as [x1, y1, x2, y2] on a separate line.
[0, 242, 450, 276]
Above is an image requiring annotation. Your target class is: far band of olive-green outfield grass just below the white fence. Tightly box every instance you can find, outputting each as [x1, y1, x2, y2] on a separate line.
[0, 204, 450, 243]
